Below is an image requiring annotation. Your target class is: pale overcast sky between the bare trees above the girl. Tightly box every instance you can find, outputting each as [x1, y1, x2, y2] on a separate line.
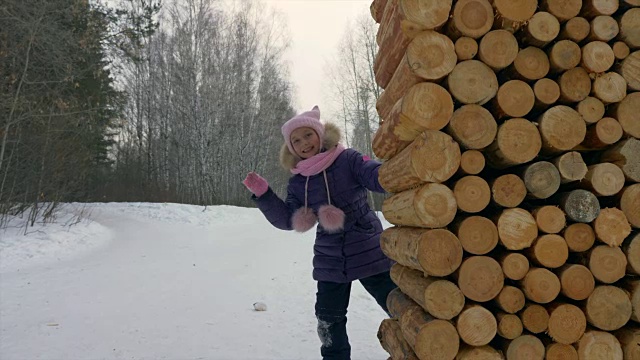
[263, 0, 371, 114]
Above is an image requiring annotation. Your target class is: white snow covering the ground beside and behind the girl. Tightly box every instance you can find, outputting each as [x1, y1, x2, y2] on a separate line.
[0, 203, 389, 360]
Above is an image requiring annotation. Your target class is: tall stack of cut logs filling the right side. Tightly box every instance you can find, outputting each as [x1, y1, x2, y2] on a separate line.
[371, 0, 640, 360]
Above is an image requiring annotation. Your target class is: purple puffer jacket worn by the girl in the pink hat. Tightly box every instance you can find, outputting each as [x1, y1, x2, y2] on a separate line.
[253, 149, 392, 283]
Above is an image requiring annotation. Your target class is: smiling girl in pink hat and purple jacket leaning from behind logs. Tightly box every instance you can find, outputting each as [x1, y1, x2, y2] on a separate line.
[243, 106, 396, 360]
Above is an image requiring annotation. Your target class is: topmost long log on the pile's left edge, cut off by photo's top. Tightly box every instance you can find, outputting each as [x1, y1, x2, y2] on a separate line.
[374, 0, 452, 88]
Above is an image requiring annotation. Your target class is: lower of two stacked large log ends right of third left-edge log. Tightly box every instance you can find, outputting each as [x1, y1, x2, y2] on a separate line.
[447, 104, 498, 150]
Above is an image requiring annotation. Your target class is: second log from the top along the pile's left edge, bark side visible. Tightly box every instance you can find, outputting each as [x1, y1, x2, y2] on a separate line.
[376, 30, 457, 119]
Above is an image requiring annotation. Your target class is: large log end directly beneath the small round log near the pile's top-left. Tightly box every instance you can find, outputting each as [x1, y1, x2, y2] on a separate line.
[447, 60, 498, 105]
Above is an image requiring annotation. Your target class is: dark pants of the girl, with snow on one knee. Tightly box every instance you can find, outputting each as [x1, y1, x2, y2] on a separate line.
[316, 271, 396, 360]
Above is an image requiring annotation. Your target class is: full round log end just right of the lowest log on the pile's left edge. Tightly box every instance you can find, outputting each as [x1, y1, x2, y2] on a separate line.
[456, 304, 498, 346]
